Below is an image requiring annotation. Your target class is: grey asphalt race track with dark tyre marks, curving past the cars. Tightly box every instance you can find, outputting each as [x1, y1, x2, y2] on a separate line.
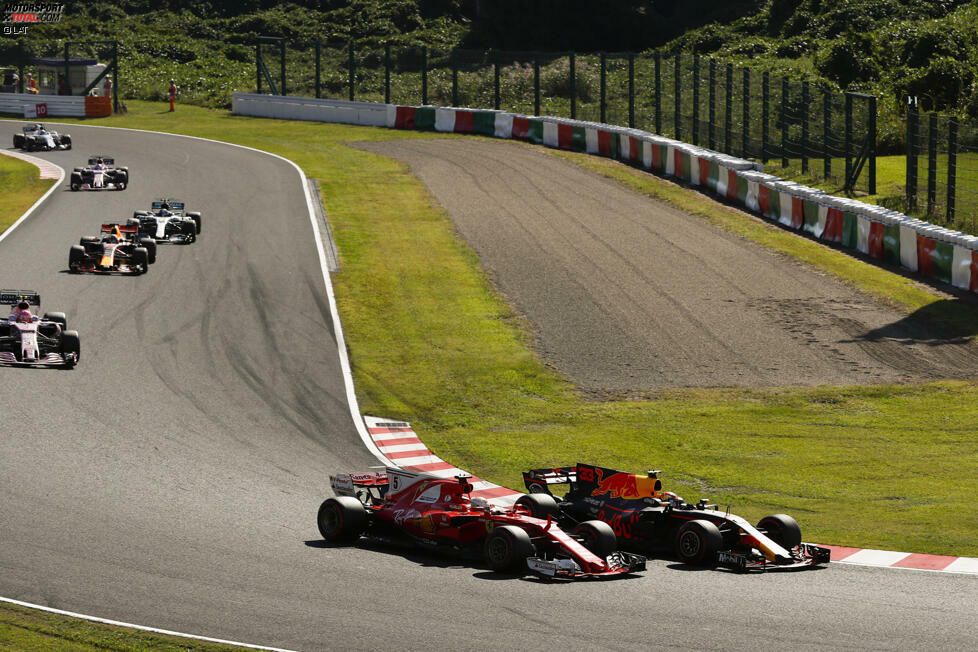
[0, 121, 978, 650]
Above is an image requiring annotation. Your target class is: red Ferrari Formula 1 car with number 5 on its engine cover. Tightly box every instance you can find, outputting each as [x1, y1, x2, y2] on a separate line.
[317, 467, 645, 579]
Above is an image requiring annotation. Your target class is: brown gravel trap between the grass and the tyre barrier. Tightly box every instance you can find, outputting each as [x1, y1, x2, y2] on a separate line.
[356, 139, 978, 396]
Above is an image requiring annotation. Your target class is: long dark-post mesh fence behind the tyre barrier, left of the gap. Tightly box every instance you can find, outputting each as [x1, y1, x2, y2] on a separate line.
[256, 37, 876, 194]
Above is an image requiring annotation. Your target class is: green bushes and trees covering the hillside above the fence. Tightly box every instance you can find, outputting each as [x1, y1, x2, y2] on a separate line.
[11, 0, 978, 122]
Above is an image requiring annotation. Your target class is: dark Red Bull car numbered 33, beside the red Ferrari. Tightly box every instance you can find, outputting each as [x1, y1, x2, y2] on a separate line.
[523, 463, 830, 571]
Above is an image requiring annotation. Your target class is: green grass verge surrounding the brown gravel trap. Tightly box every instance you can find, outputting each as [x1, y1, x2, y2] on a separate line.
[1, 102, 978, 644]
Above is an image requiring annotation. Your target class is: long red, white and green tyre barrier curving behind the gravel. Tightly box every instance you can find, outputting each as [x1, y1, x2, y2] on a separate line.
[233, 93, 978, 292]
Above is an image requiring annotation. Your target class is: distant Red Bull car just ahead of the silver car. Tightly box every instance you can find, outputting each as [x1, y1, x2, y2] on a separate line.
[68, 223, 156, 274]
